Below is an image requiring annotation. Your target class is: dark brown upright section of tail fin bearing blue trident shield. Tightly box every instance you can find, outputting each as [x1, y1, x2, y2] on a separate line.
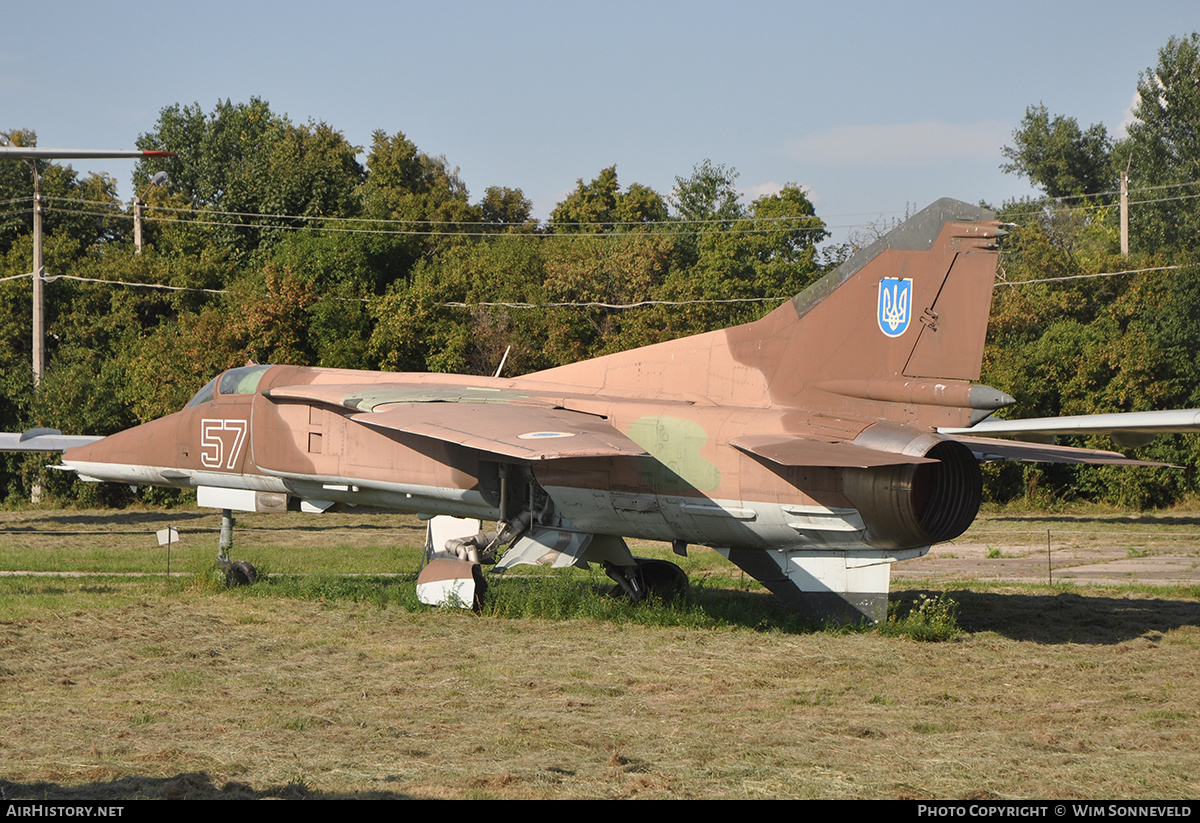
[726, 199, 1010, 422]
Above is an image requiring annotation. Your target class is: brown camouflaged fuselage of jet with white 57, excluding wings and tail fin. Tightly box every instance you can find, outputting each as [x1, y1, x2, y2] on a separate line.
[64, 366, 888, 548]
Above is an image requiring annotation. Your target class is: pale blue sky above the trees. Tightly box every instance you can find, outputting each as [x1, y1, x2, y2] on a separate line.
[0, 0, 1200, 242]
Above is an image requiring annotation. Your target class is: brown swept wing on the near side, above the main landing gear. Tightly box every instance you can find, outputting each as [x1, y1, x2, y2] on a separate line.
[350, 403, 647, 461]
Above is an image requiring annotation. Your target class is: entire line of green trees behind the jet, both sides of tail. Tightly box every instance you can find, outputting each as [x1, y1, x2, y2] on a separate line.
[0, 34, 1200, 505]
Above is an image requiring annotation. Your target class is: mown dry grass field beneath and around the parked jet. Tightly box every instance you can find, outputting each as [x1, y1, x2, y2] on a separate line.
[0, 510, 1200, 799]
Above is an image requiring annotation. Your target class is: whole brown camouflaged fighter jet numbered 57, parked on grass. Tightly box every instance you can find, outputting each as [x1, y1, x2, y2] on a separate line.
[28, 200, 1156, 620]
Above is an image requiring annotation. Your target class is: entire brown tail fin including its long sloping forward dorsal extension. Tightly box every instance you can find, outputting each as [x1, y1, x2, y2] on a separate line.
[520, 199, 1012, 426]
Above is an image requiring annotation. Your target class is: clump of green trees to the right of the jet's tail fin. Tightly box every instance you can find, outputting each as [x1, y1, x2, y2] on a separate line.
[983, 34, 1200, 505]
